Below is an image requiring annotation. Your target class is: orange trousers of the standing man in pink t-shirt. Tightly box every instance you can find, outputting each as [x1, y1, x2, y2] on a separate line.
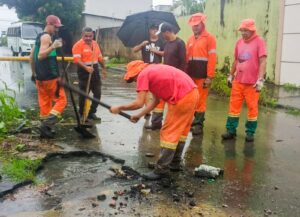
[229, 81, 259, 121]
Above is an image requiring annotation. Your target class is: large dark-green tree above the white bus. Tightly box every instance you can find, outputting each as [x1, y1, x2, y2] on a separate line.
[0, 0, 85, 32]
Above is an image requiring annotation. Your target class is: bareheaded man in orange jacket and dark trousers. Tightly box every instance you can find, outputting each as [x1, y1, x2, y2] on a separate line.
[72, 27, 106, 121]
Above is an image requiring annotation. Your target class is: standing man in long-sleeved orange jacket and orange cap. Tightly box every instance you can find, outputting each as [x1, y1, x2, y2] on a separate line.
[186, 13, 217, 135]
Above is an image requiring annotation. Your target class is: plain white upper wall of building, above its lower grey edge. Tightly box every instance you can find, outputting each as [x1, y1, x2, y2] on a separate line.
[84, 0, 152, 19]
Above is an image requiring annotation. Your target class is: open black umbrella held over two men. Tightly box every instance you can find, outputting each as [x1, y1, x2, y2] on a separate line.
[117, 11, 180, 47]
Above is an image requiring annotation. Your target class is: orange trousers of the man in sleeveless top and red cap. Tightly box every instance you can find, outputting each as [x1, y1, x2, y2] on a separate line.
[36, 79, 67, 119]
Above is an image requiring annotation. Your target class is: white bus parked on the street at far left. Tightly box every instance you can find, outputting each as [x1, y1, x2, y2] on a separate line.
[7, 22, 43, 56]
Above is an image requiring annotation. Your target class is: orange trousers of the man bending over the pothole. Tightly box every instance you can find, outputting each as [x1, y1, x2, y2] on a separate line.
[160, 89, 199, 150]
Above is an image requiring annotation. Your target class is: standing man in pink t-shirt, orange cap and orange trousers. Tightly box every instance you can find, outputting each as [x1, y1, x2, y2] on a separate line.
[222, 19, 267, 142]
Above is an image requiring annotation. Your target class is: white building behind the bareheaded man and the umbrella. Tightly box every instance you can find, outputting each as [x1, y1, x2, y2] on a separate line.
[83, 0, 152, 29]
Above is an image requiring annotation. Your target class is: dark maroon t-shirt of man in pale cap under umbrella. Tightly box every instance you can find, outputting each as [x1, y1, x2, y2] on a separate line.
[164, 38, 186, 71]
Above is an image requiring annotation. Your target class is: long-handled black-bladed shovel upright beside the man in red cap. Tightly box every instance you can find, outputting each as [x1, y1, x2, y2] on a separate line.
[60, 52, 96, 139]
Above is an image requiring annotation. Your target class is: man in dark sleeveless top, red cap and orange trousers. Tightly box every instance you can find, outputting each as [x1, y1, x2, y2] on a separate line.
[30, 15, 67, 138]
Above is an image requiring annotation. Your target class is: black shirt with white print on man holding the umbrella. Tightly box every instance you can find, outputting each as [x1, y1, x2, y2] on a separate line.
[142, 38, 164, 63]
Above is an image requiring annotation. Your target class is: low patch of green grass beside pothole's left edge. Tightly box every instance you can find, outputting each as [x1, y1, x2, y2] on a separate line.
[2, 157, 41, 182]
